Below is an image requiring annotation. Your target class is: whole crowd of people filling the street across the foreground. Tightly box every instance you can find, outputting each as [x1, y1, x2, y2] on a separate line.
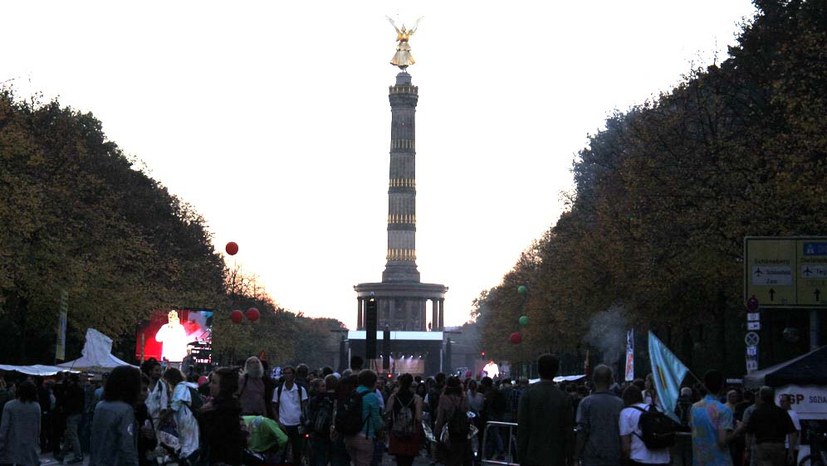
[0, 354, 800, 466]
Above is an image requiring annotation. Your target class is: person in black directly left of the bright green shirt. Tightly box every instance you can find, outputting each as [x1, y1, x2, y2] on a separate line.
[197, 367, 244, 465]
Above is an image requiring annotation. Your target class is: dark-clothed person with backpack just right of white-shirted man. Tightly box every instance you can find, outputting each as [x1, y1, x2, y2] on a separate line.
[305, 374, 339, 466]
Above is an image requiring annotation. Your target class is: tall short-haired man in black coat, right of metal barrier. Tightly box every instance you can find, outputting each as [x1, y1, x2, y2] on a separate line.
[517, 354, 574, 466]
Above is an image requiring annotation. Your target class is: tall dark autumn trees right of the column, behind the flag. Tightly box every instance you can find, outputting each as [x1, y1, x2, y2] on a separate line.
[476, 0, 827, 374]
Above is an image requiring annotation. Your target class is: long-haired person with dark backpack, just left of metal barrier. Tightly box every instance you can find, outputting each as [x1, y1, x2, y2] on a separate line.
[434, 376, 471, 466]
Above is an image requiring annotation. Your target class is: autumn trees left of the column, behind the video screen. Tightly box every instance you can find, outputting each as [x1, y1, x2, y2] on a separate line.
[0, 89, 343, 365]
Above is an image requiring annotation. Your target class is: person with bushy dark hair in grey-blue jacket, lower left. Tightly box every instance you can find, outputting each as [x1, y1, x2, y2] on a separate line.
[89, 366, 141, 466]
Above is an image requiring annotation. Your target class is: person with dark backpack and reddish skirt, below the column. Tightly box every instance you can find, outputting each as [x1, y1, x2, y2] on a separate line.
[385, 374, 422, 466]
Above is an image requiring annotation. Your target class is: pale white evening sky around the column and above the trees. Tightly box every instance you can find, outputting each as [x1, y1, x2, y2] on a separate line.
[0, 0, 754, 328]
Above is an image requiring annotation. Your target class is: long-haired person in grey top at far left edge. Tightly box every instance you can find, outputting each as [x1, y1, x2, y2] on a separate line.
[0, 380, 40, 466]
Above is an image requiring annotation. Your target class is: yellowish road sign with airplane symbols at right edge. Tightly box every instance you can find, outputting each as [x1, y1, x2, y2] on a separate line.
[744, 236, 827, 308]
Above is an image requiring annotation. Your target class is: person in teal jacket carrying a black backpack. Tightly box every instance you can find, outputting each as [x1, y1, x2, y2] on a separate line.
[335, 369, 384, 466]
